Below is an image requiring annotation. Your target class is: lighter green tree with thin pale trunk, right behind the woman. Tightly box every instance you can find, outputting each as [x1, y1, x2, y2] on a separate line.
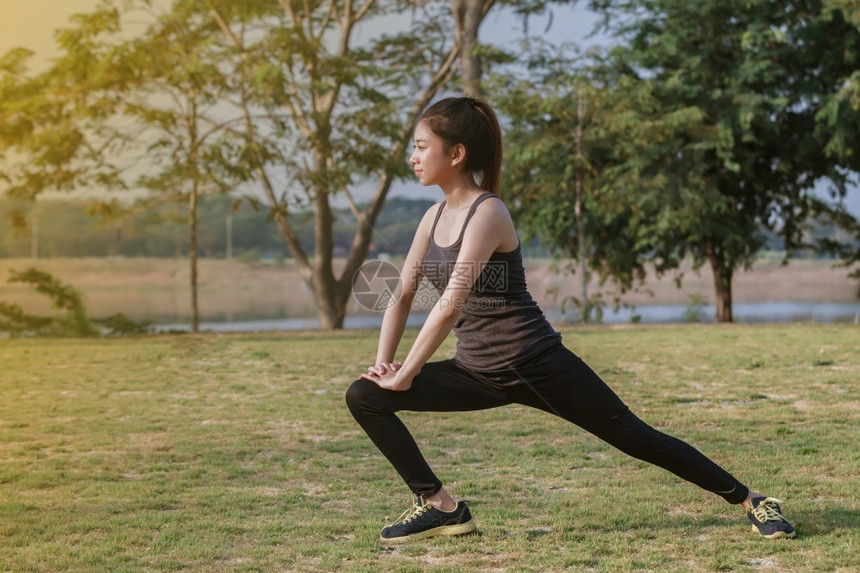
[494, 44, 684, 322]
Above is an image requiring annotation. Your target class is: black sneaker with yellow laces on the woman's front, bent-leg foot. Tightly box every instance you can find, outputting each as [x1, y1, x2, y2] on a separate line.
[379, 496, 477, 543]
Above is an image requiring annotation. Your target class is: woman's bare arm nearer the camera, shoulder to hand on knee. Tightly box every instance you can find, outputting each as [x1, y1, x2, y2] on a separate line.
[364, 201, 516, 390]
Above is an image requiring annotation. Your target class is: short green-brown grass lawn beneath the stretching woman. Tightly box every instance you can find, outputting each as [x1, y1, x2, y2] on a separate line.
[0, 325, 860, 573]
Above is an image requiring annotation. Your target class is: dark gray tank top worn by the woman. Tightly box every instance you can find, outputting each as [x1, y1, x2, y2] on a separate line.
[423, 192, 561, 384]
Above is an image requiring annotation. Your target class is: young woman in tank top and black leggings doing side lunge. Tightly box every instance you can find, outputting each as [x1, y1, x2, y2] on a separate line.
[346, 98, 795, 543]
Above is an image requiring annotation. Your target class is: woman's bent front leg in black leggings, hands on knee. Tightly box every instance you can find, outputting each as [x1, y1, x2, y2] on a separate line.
[346, 360, 510, 497]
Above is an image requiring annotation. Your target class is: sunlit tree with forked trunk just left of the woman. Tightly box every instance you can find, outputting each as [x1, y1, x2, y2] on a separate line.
[198, 0, 470, 329]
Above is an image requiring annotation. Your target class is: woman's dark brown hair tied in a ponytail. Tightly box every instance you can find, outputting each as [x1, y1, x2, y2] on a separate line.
[418, 97, 502, 195]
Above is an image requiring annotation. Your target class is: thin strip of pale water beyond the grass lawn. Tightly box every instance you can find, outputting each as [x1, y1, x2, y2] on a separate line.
[155, 302, 860, 332]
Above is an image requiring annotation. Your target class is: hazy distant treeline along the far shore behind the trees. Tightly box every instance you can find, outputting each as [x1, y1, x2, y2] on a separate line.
[0, 196, 838, 259]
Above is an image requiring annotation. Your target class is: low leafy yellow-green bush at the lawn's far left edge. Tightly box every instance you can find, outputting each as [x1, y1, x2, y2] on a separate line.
[0, 267, 99, 336]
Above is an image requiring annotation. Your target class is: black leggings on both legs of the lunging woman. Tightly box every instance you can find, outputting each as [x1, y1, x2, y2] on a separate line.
[346, 345, 749, 503]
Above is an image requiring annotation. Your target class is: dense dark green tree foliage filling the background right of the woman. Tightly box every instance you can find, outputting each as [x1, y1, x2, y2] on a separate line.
[502, 0, 860, 321]
